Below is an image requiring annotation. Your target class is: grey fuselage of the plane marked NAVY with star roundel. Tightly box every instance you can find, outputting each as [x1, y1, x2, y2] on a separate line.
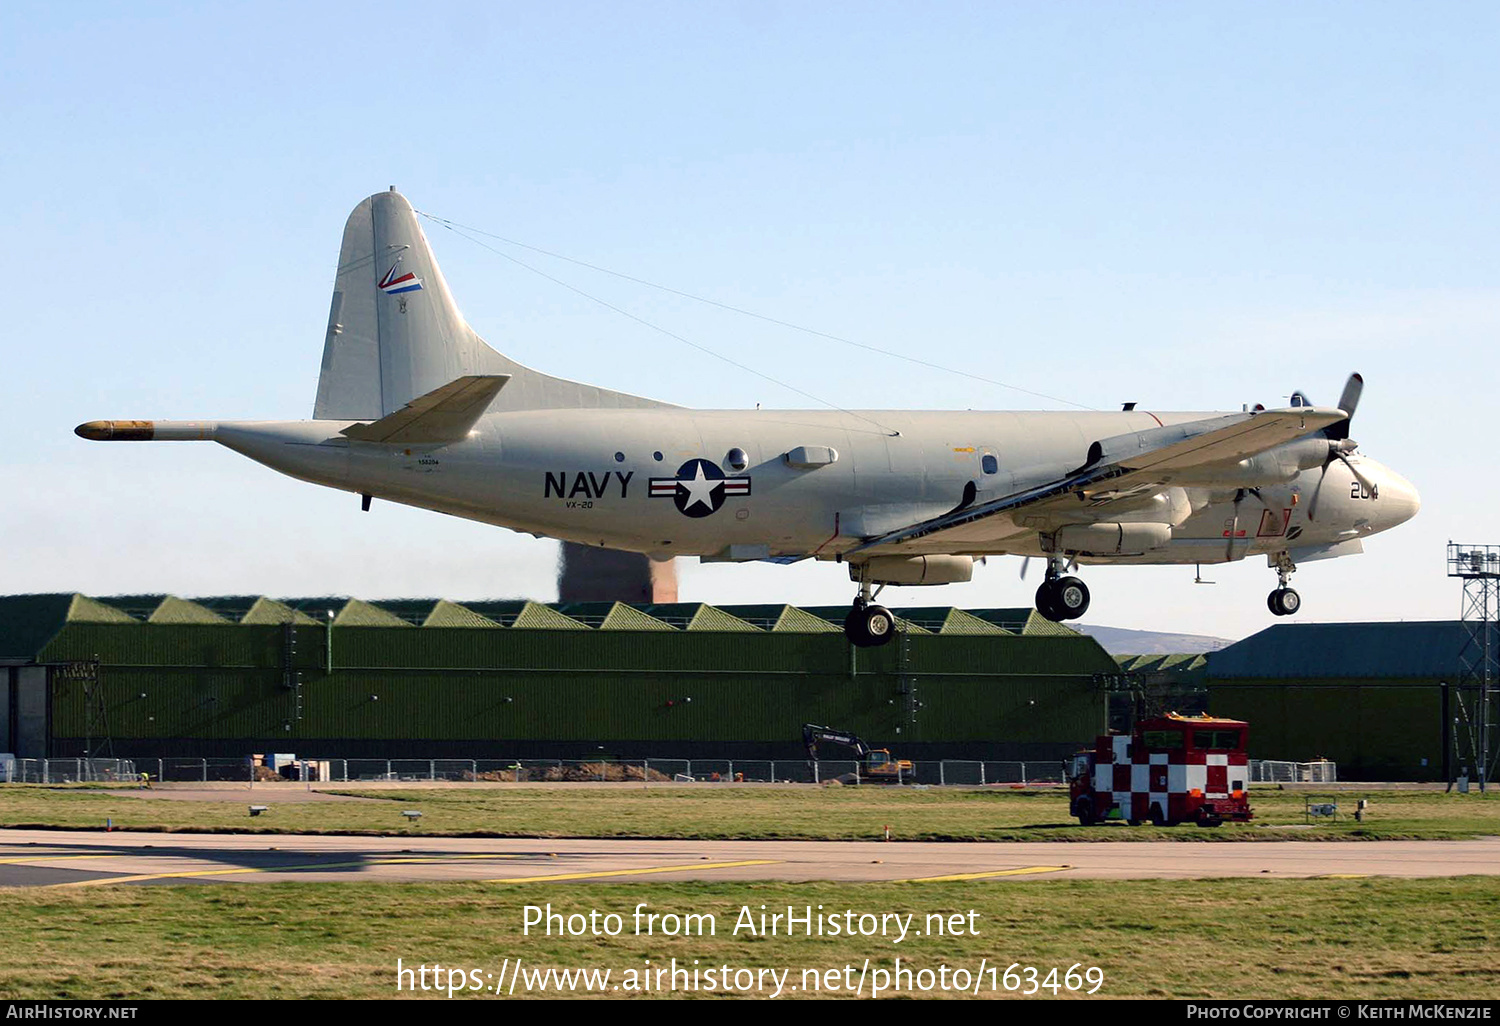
[202, 408, 1418, 564]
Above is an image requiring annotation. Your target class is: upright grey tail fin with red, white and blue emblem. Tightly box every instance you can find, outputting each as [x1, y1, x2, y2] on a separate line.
[312, 189, 666, 420]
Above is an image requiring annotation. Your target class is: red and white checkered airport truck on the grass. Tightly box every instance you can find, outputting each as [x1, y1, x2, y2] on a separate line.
[1068, 713, 1251, 827]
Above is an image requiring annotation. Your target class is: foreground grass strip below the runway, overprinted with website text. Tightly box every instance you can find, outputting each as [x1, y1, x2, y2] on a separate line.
[0, 878, 1500, 1001]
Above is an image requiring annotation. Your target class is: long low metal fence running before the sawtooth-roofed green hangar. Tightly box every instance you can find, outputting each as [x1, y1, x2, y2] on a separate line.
[0, 759, 1067, 788]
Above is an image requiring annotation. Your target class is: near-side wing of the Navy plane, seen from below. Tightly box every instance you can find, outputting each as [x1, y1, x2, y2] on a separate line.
[845, 407, 1349, 557]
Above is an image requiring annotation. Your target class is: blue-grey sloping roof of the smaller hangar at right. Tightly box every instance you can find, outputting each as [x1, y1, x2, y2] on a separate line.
[1209, 620, 1500, 681]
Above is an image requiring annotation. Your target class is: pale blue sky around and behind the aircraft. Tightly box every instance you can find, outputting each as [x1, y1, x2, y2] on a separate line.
[0, 3, 1500, 638]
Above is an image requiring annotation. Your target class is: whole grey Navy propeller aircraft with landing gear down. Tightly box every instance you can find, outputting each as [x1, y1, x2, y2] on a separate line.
[77, 189, 1419, 647]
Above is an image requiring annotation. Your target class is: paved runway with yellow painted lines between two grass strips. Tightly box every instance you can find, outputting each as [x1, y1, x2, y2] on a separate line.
[0, 830, 1500, 888]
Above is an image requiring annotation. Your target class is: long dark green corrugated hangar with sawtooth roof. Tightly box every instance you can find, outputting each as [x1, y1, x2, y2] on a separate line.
[0, 594, 1119, 761]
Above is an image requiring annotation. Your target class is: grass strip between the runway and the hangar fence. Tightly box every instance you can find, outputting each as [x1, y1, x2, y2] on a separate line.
[0, 785, 1500, 842]
